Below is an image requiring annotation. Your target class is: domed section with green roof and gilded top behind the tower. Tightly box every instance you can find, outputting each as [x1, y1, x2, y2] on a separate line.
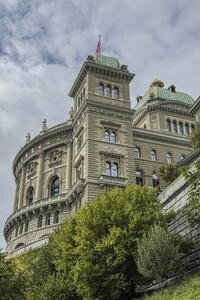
[133, 76, 195, 135]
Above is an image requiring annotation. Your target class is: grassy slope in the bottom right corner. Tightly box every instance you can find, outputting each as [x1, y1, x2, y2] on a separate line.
[139, 273, 200, 300]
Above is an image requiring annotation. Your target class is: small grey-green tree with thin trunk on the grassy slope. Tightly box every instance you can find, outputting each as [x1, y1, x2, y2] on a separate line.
[137, 225, 183, 293]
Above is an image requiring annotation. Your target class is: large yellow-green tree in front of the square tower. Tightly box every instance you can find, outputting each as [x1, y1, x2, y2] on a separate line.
[52, 184, 174, 300]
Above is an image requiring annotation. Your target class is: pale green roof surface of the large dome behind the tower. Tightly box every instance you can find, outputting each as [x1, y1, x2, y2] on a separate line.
[134, 86, 195, 110]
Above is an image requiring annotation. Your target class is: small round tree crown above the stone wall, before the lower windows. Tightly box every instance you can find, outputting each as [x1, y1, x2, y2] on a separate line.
[156, 163, 181, 184]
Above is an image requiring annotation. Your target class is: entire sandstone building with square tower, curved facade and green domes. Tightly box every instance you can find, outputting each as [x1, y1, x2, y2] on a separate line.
[4, 53, 200, 255]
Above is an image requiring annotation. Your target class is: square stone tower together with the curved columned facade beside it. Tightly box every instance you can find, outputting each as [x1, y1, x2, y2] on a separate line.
[4, 53, 135, 255]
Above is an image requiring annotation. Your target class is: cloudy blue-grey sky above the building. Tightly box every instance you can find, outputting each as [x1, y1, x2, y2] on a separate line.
[0, 0, 200, 248]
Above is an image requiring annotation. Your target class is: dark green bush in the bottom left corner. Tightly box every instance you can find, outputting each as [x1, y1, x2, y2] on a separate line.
[0, 252, 26, 300]
